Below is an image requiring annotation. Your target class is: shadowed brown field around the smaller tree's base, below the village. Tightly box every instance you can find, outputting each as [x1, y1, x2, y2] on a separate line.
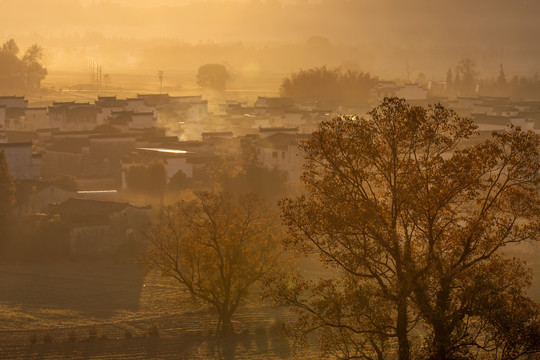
[0, 261, 320, 359]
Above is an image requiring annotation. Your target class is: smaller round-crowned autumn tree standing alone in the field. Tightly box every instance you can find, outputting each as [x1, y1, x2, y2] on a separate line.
[147, 192, 280, 336]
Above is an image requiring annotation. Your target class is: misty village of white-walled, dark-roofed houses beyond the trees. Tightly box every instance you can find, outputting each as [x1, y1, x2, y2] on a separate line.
[0, 88, 540, 255]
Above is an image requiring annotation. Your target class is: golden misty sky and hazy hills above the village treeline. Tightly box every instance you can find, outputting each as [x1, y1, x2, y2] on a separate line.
[0, 0, 540, 85]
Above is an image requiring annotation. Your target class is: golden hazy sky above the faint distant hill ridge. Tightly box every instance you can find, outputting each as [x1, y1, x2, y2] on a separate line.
[0, 0, 540, 45]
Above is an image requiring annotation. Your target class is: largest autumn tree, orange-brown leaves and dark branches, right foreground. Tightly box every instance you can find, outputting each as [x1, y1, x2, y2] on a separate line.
[269, 98, 540, 360]
